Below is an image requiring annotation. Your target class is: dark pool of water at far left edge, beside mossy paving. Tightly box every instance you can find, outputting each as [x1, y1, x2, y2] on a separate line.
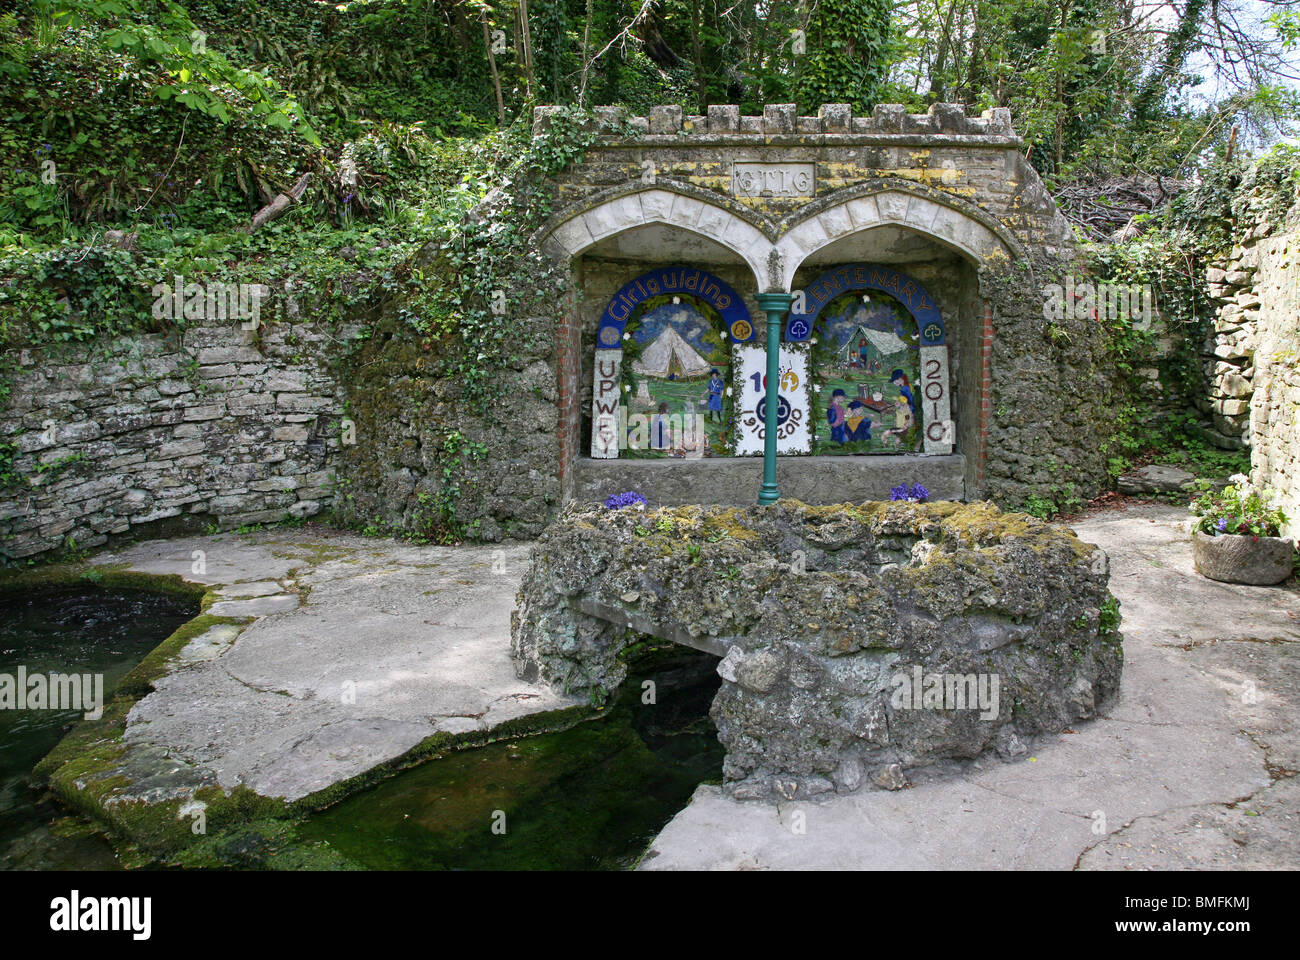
[0, 582, 198, 870]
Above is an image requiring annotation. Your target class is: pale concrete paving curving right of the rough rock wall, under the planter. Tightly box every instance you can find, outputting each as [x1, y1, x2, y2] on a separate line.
[641, 503, 1300, 870]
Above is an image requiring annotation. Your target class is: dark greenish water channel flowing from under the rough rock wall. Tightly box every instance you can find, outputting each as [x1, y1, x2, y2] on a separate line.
[299, 648, 724, 870]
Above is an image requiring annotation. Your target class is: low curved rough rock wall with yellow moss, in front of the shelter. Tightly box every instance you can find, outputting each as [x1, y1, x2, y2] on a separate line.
[512, 500, 1123, 799]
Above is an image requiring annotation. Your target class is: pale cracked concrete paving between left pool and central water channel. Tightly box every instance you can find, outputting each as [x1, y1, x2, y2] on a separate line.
[94, 529, 575, 800]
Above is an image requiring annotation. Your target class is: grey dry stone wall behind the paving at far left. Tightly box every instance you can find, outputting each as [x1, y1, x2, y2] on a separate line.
[0, 323, 342, 559]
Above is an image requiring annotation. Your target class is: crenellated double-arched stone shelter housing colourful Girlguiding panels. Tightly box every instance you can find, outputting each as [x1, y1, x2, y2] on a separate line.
[534, 104, 1109, 503]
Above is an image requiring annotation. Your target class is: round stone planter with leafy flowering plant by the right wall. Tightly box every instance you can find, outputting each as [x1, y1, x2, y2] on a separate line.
[1191, 473, 1295, 585]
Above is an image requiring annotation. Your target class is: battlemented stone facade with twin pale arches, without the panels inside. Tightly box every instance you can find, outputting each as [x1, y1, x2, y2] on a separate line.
[534, 104, 1106, 509]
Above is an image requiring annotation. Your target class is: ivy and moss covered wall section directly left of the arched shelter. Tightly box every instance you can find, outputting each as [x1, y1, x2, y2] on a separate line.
[337, 108, 633, 542]
